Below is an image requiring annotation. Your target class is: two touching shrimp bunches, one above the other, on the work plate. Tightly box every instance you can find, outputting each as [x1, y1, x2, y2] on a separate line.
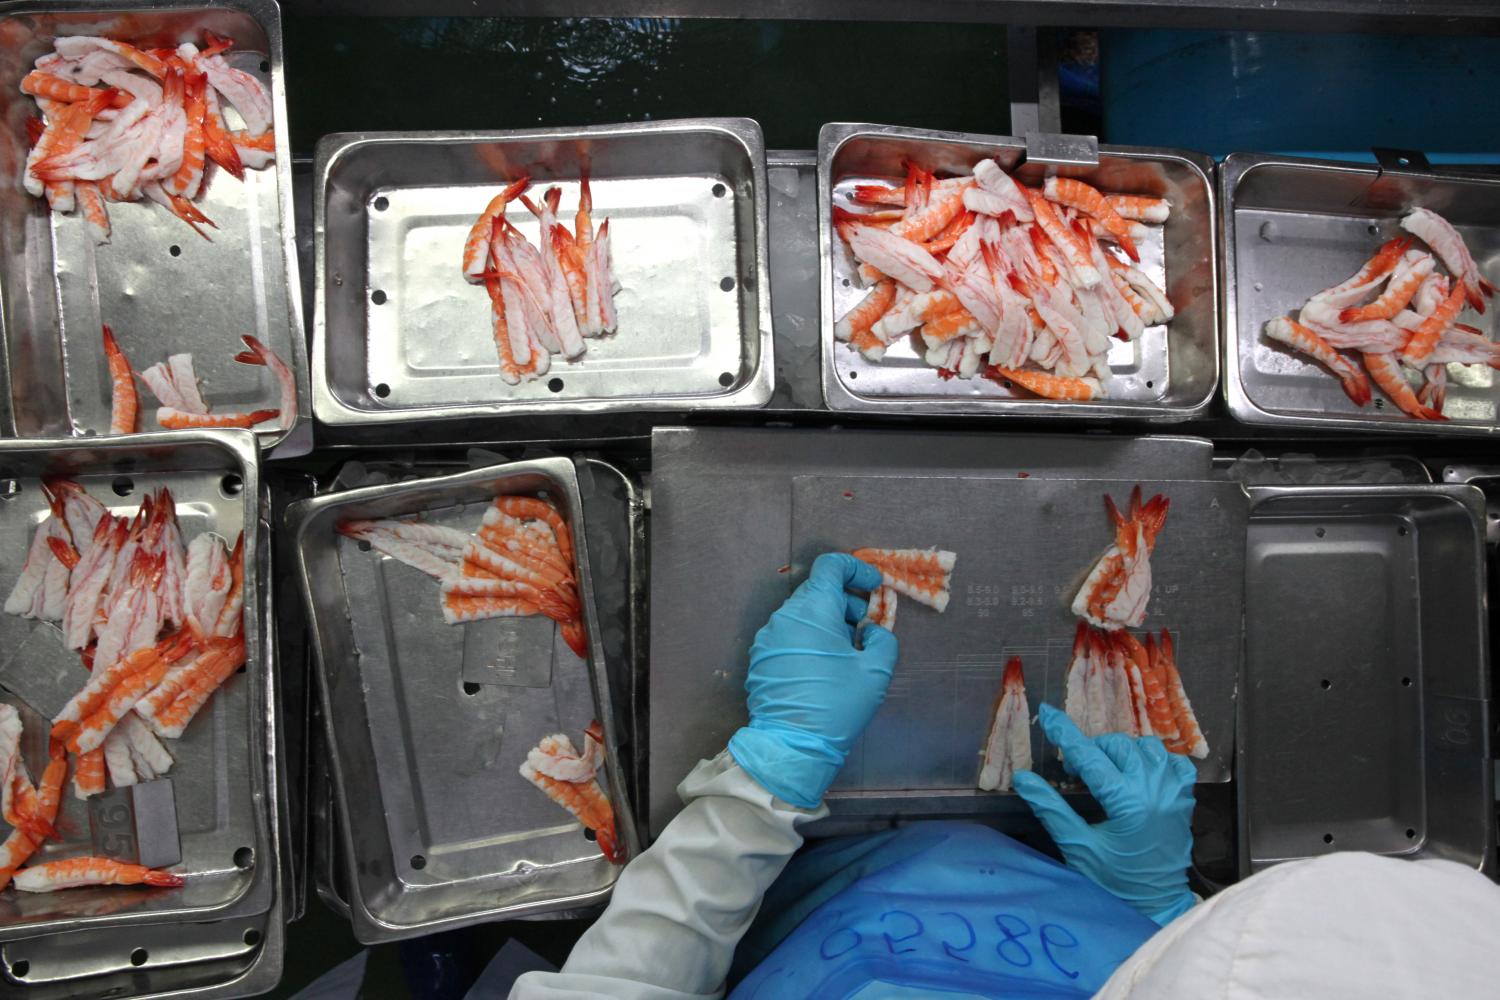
[1064, 486, 1209, 757]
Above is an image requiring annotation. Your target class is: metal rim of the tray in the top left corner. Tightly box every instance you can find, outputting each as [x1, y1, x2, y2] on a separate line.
[0, 0, 314, 457]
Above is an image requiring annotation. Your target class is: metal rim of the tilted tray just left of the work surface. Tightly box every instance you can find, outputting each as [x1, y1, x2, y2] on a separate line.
[285, 456, 641, 945]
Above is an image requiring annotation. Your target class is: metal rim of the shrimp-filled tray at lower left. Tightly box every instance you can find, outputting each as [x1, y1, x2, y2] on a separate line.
[0, 430, 281, 943]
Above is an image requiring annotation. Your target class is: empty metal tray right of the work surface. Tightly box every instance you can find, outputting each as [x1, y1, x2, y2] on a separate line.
[1236, 486, 1494, 874]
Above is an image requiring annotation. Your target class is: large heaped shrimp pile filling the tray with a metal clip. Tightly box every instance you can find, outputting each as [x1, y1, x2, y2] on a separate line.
[833, 160, 1173, 400]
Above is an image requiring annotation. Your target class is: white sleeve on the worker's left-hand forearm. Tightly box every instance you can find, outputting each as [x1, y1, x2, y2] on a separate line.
[510, 751, 827, 1000]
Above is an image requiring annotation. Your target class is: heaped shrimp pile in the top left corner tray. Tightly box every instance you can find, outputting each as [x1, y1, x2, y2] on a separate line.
[21, 31, 276, 243]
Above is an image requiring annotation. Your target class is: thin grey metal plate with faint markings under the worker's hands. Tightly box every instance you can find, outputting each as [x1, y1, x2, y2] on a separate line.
[792, 471, 1248, 791]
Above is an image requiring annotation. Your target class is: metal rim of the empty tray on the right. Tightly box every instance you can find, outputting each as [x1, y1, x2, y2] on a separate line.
[1235, 483, 1496, 879]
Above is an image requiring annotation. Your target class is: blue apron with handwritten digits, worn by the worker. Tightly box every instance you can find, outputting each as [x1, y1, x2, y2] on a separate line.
[731, 822, 1157, 1000]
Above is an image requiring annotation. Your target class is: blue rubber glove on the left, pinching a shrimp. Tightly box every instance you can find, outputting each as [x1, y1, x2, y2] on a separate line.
[729, 552, 896, 810]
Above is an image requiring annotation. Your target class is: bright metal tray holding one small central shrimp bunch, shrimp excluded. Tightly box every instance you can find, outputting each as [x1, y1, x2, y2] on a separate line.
[314, 118, 773, 427]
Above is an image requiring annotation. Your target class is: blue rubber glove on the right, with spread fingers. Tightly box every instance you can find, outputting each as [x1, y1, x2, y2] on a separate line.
[1014, 705, 1197, 925]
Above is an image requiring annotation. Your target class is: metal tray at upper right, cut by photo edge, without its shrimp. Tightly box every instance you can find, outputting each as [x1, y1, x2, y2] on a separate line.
[1220, 153, 1500, 435]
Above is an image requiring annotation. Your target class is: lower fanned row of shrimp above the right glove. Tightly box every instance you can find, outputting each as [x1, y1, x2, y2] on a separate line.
[1064, 621, 1209, 759]
